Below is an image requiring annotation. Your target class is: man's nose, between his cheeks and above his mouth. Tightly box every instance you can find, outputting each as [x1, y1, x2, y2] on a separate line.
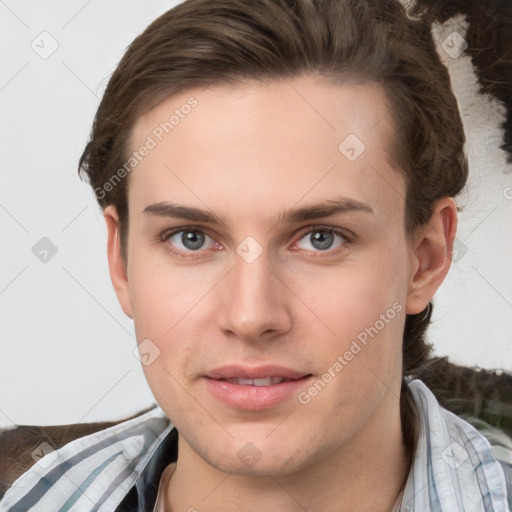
[217, 246, 292, 343]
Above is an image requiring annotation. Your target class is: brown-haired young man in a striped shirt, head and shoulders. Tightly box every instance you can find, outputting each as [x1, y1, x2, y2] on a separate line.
[0, 0, 507, 512]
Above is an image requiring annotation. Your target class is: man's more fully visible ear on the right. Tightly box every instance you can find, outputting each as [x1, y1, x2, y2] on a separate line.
[406, 197, 457, 315]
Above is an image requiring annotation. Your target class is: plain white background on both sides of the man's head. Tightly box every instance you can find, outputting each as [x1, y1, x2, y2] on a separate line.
[0, 0, 512, 425]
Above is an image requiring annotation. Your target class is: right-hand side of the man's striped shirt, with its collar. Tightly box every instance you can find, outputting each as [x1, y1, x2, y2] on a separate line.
[404, 379, 510, 512]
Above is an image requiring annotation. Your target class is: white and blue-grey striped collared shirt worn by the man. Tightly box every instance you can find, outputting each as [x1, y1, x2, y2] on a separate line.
[0, 379, 510, 512]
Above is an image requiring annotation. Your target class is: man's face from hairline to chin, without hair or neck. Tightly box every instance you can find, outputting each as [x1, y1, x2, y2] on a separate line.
[106, 76, 429, 475]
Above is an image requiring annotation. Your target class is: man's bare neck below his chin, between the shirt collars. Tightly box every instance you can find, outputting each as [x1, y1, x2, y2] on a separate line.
[166, 385, 417, 512]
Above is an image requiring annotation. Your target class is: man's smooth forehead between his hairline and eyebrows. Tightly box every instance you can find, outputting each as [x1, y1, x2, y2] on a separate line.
[128, 76, 405, 227]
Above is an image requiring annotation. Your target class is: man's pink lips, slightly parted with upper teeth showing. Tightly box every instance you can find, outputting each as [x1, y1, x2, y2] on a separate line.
[203, 365, 313, 411]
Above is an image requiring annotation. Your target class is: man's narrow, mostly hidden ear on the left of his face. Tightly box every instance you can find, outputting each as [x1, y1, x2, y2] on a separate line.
[103, 205, 133, 318]
